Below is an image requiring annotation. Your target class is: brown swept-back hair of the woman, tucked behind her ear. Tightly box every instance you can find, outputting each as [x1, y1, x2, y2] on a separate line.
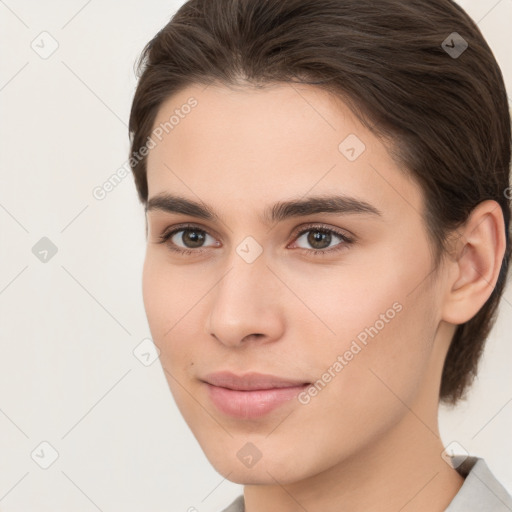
[129, 0, 511, 404]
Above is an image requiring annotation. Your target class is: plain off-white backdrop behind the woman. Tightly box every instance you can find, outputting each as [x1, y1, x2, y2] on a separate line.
[0, 0, 512, 512]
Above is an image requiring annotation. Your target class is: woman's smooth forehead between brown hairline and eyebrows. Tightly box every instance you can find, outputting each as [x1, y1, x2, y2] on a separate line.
[147, 83, 421, 221]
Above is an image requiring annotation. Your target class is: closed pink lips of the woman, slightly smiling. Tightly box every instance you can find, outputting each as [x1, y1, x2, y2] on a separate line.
[201, 372, 310, 419]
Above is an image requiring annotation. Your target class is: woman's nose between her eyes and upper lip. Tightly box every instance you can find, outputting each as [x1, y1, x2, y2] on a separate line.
[206, 248, 289, 347]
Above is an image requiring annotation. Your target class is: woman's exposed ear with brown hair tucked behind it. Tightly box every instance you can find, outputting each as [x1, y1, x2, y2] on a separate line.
[442, 200, 506, 325]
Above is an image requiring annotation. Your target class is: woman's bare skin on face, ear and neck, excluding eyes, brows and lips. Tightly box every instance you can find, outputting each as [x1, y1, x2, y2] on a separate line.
[143, 84, 505, 512]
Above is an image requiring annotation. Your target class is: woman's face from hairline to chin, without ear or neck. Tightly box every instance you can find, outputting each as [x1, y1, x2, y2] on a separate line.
[143, 84, 446, 483]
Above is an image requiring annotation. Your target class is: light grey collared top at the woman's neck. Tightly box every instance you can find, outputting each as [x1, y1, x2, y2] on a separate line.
[222, 455, 512, 512]
